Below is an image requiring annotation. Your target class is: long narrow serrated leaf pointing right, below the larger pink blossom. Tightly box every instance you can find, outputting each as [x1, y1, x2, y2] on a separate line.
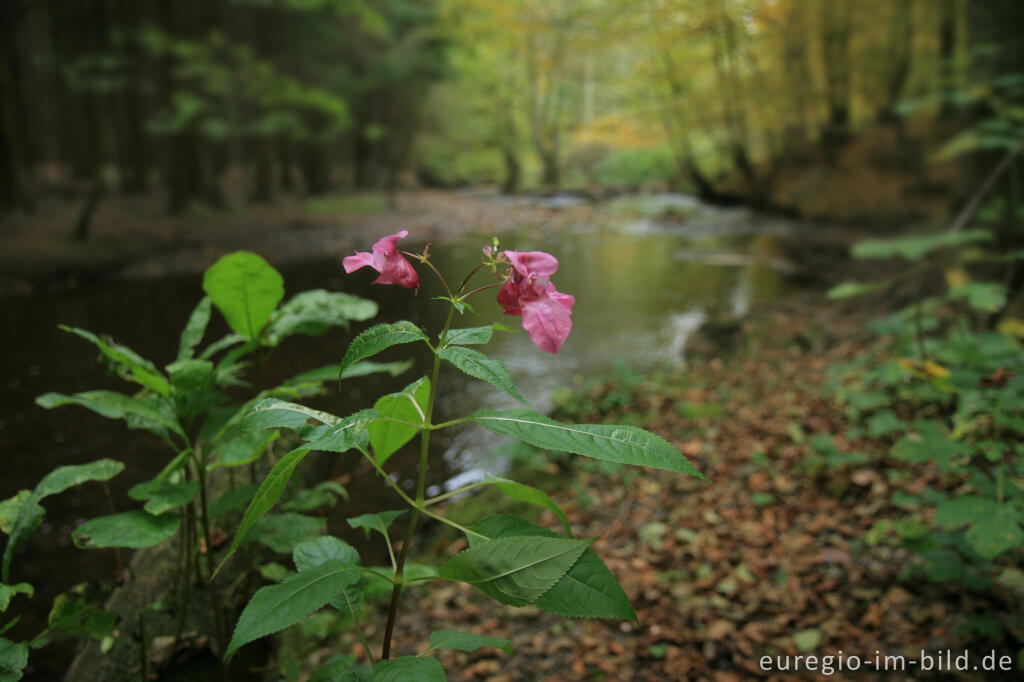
[473, 410, 708, 480]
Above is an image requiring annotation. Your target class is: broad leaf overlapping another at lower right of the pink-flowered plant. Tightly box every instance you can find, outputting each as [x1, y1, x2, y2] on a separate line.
[439, 536, 592, 606]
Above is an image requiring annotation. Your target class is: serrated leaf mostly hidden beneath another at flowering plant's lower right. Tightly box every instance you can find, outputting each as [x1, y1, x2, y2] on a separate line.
[469, 514, 637, 621]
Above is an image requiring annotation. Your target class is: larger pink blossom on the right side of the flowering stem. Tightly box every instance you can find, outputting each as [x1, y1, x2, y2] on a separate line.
[498, 251, 575, 353]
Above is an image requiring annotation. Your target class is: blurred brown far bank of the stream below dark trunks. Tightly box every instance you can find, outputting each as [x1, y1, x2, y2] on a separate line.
[0, 190, 606, 295]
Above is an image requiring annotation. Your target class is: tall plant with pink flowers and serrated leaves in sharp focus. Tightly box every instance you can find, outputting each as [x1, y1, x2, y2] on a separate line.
[224, 231, 703, 682]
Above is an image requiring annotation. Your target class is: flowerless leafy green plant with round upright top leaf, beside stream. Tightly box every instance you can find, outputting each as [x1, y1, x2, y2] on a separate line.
[9, 252, 397, 667]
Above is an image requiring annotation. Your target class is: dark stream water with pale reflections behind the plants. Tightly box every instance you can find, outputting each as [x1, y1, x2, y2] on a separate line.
[0, 193, 791, 679]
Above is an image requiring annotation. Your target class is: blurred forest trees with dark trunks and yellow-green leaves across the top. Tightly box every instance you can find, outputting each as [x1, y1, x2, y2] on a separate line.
[0, 0, 1024, 211]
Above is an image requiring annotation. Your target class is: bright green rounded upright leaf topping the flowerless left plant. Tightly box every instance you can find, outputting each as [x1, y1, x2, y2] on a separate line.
[203, 251, 285, 340]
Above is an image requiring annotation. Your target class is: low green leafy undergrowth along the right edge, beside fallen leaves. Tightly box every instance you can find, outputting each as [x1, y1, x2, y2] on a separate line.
[830, 216, 1024, 627]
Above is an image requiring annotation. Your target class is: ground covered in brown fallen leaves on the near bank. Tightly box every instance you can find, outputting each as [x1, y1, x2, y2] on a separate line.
[346, 305, 1020, 682]
